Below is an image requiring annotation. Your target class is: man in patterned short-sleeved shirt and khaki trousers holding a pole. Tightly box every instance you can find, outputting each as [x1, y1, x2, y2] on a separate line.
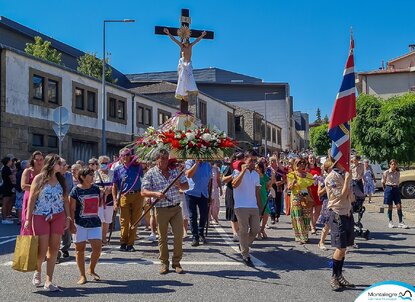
[141, 149, 189, 275]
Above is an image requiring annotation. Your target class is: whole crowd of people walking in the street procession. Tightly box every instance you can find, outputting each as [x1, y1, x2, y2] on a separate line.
[1, 148, 407, 291]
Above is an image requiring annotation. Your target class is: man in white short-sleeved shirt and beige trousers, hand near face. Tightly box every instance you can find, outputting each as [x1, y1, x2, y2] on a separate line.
[232, 150, 262, 267]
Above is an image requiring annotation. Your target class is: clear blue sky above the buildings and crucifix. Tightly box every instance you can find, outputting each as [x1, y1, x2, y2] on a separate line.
[0, 0, 415, 121]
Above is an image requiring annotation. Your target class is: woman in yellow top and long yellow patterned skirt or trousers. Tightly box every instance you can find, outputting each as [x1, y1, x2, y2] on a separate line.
[287, 158, 314, 244]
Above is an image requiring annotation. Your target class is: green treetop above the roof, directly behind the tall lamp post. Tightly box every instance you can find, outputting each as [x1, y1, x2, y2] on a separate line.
[77, 52, 117, 83]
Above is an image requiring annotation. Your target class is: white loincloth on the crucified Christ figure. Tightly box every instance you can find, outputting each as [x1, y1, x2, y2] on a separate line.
[175, 58, 199, 100]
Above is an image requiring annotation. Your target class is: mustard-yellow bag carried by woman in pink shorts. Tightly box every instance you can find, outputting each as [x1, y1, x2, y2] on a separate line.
[12, 235, 39, 272]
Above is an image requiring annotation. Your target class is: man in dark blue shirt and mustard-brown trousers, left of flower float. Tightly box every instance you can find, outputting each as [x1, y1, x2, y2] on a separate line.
[112, 148, 144, 252]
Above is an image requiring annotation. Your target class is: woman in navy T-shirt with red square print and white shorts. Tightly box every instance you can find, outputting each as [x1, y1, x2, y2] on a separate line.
[69, 168, 102, 284]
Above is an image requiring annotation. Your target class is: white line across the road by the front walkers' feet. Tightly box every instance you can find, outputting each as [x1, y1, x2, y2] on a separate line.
[2, 258, 243, 266]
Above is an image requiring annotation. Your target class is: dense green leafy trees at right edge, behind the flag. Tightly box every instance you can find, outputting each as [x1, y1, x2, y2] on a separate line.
[352, 93, 415, 164]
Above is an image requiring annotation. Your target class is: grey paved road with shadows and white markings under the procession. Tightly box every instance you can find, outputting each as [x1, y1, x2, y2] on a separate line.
[0, 204, 415, 302]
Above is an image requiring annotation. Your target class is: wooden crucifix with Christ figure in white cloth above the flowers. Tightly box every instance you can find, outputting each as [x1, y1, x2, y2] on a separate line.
[155, 9, 214, 113]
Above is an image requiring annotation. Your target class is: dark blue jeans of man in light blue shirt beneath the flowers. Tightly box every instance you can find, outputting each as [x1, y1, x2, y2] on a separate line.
[185, 194, 208, 240]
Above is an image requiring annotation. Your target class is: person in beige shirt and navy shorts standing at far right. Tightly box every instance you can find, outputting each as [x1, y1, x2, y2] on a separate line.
[382, 159, 408, 229]
